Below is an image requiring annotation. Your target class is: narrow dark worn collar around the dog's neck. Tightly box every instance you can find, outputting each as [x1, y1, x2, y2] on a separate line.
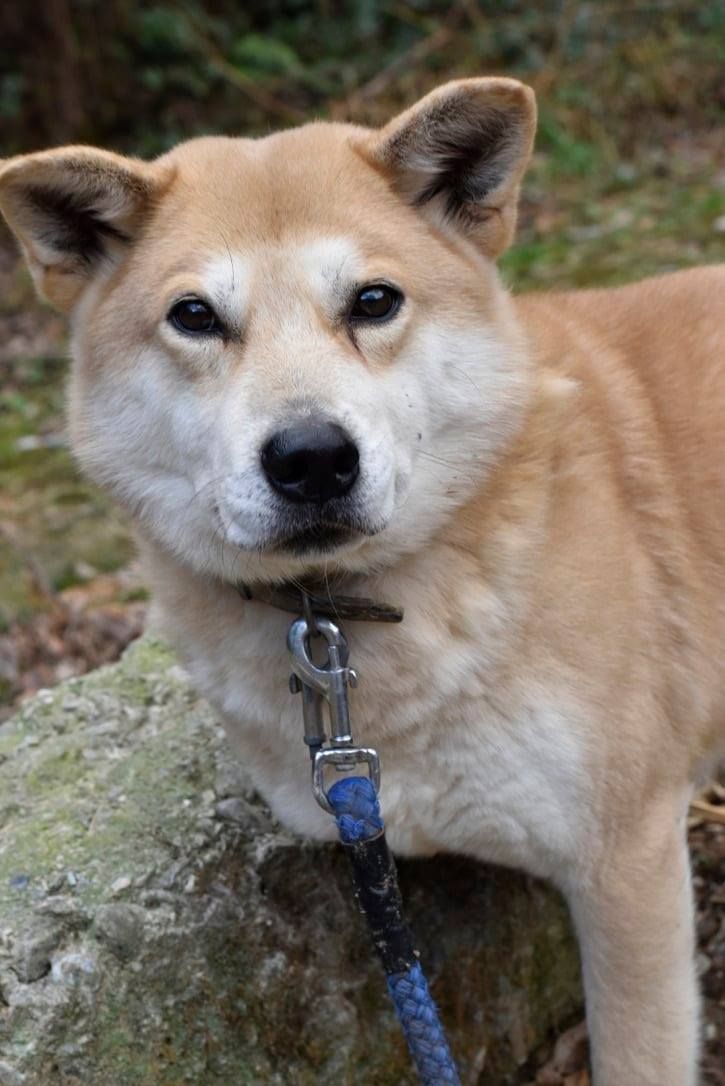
[236, 581, 404, 622]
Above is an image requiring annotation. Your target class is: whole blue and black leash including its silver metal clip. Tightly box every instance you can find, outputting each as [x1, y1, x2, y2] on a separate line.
[286, 612, 460, 1086]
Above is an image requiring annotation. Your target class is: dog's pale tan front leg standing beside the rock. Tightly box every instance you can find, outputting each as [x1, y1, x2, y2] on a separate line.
[569, 806, 699, 1086]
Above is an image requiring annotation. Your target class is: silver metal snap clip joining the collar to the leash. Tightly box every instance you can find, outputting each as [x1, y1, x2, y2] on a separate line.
[287, 615, 380, 815]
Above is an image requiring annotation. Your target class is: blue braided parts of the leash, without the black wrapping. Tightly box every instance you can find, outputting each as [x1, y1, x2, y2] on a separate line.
[328, 776, 460, 1086]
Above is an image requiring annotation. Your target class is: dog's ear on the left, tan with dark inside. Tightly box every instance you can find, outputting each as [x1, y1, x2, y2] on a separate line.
[0, 147, 167, 311]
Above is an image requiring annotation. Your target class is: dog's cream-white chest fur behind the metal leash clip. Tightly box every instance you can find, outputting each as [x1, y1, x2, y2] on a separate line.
[176, 590, 586, 874]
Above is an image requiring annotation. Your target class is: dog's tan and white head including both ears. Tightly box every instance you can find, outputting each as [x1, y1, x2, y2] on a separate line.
[0, 79, 535, 580]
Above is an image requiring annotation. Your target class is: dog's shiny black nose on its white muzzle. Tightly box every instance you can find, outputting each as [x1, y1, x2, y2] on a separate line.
[262, 418, 360, 505]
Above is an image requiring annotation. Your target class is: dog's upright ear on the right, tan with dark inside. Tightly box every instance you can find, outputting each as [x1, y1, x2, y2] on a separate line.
[363, 78, 536, 257]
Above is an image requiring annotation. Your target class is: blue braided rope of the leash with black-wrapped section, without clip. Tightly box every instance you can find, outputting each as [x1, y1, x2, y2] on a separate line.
[328, 776, 460, 1086]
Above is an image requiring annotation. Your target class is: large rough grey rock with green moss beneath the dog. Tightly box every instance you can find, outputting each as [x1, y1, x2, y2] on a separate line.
[0, 639, 581, 1086]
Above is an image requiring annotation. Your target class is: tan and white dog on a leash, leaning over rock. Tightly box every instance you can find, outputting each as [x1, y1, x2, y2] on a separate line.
[0, 79, 725, 1086]
